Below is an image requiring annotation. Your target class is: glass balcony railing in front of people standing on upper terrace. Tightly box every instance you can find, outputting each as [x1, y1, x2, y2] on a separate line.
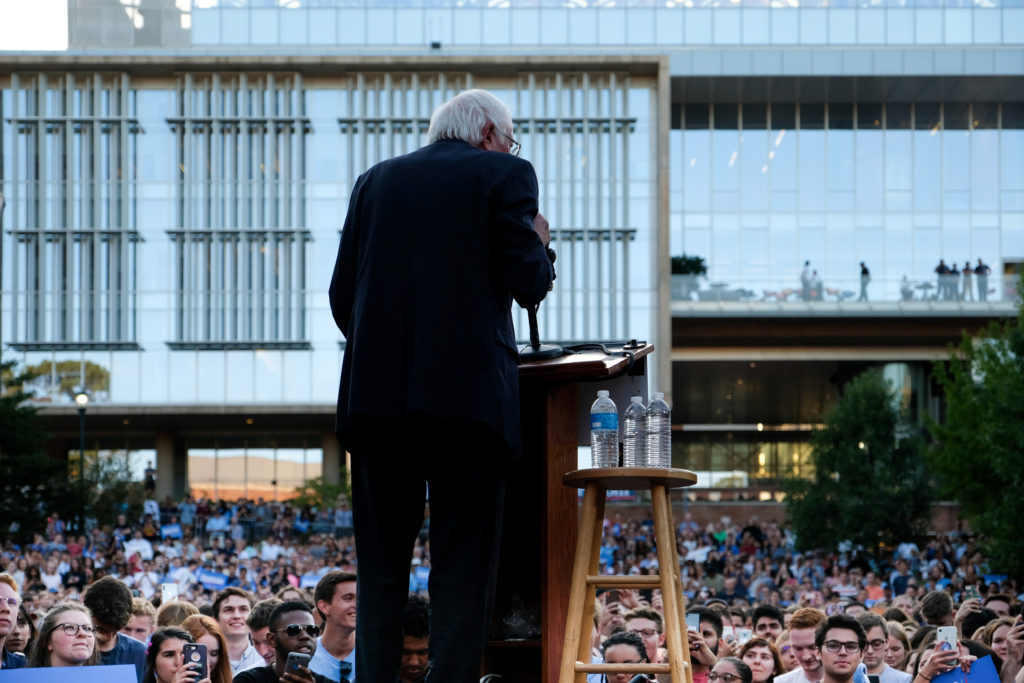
[672, 273, 1020, 309]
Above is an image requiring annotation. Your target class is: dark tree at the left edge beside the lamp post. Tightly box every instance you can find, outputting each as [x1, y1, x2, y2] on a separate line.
[0, 361, 81, 541]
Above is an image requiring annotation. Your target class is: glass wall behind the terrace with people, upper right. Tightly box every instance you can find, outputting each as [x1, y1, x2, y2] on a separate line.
[671, 101, 1024, 304]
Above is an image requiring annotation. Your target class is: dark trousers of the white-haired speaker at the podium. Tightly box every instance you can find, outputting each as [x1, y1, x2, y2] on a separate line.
[351, 419, 508, 683]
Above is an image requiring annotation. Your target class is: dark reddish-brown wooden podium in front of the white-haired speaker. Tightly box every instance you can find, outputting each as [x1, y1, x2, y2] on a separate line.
[482, 344, 653, 683]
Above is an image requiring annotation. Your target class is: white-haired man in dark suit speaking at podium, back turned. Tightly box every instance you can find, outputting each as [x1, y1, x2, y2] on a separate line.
[331, 90, 554, 683]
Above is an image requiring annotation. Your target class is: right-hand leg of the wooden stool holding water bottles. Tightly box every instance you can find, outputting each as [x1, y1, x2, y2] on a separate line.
[651, 485, 693, 683]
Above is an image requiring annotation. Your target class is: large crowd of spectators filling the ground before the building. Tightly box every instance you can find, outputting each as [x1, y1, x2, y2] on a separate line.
[0, 498, 1024, 683]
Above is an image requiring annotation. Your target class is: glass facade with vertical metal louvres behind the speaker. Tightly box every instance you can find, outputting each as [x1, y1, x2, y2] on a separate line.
[0, 71, 656, 404]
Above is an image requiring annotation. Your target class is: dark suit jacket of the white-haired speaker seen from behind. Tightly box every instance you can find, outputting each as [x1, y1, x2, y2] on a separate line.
[331, 140, 553, 453]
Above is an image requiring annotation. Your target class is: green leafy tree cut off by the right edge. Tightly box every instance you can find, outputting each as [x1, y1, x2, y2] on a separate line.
[930, 308, 1024, 577]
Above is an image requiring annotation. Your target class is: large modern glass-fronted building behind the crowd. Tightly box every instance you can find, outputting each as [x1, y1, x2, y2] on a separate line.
[0, 0, 1024, 496]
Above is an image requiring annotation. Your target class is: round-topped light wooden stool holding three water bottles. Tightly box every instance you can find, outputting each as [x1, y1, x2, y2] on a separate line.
[558, 467, 697, 683]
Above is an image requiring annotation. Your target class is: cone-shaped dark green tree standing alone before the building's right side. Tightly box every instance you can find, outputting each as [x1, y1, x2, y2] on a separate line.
[784, 370, 932, 551]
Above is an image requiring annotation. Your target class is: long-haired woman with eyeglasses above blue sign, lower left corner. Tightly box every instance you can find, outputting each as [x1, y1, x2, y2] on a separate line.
[28, 602, 99, 668]
